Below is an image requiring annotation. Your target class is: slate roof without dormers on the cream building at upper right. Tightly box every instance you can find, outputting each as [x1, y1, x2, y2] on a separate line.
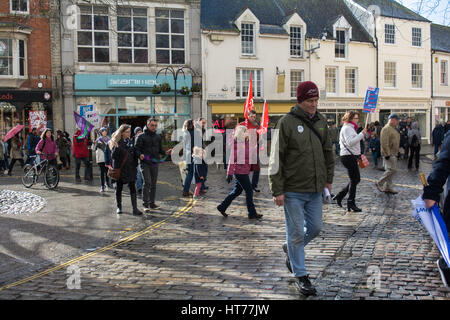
[353, 0, 430, 22]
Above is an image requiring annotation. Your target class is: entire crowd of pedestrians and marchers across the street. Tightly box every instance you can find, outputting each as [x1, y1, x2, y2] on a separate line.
[0, 81, 450, 295]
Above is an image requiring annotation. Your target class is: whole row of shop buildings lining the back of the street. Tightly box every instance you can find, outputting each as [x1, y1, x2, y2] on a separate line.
[0, 0, 450, 141]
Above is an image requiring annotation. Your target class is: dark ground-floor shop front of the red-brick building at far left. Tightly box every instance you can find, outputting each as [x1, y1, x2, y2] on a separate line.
[0, 90, 53, 135]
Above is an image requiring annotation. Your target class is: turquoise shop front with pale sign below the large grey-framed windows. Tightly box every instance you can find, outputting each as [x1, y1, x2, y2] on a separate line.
[75, 74, 192, 141]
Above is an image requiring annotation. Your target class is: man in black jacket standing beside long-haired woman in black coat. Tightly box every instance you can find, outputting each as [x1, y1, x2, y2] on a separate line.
[135, 118, 171, 211]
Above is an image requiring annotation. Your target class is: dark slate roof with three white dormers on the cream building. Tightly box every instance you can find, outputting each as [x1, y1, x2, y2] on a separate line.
[201, 0, 372, 42]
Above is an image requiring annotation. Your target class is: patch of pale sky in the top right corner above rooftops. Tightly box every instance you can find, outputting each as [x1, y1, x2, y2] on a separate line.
[397, 0, 450, 26]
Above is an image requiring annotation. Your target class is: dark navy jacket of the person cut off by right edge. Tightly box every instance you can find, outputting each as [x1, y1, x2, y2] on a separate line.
[422, 133, 450, 216]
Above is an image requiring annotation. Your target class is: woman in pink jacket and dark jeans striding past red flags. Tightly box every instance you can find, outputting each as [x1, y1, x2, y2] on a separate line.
[217, 126, 263, 219]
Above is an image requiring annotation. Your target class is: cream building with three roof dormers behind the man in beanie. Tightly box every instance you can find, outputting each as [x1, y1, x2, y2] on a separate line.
[202, 1, 375, 127]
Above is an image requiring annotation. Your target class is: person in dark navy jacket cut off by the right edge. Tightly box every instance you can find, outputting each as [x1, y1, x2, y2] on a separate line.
[422, 133, 450, 285]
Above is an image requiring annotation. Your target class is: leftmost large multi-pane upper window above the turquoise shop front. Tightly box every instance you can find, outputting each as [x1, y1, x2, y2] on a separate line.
[77, 5, 109, 62]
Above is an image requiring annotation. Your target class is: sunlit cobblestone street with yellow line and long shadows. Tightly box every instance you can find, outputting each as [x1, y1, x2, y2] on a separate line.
[0, 152, 450, 300]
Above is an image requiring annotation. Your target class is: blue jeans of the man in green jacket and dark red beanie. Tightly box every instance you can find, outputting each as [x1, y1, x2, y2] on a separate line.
[284, 192, 322, 277]
